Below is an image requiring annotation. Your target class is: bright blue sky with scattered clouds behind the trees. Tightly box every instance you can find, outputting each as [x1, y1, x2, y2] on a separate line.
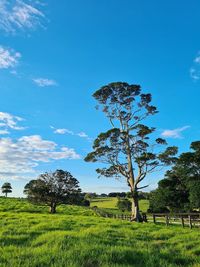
[0, 0, 200, 196]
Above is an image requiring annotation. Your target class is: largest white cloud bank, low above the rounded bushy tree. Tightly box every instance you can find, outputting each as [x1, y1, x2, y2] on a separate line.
[0, 135, 80, 180]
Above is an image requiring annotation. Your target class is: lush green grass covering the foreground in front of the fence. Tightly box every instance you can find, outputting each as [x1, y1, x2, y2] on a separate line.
[0, 198, 200, 267]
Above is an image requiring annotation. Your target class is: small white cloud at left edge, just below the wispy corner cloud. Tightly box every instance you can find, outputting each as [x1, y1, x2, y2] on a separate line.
[0, 46, 21, 69]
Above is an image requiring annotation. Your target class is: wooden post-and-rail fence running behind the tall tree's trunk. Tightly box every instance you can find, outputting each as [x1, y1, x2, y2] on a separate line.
[95, 209, 200, 229]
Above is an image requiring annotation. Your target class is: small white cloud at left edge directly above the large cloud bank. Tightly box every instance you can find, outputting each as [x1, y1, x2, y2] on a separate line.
[0, 112, 25, 134]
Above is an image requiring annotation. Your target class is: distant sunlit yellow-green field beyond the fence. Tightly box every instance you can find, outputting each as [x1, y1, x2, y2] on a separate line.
[91, 197, 149, 214]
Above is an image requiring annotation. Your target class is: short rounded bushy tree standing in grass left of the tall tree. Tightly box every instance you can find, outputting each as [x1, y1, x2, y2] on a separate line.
[24, 170, 81, 213]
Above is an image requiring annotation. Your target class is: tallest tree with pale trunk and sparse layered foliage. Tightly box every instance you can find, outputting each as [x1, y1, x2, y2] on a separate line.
[85, 82, 177, 221]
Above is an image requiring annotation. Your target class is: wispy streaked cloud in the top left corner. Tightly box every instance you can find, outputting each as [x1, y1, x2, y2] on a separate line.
[0, 0, 45, 33]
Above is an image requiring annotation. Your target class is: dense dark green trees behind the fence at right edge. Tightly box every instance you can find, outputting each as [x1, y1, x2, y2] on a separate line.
[150, 141, 200, 212]
